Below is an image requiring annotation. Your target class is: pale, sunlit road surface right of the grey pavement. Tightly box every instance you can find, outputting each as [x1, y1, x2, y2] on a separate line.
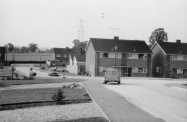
[105, 78, 187, 122]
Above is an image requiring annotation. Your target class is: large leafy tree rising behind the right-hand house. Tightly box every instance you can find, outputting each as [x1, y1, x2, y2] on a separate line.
[149, 28, 168, 44]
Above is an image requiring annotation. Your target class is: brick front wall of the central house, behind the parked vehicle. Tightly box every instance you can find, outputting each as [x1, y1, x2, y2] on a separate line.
[96, 52, 150, 76]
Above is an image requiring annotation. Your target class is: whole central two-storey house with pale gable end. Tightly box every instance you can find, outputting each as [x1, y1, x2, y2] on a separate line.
[86, 37, 151, 76]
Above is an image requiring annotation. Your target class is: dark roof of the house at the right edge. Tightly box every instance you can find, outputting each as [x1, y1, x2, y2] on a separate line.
[159, 42, 187, 55]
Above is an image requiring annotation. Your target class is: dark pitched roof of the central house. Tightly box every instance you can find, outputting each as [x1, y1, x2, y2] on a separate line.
[90, 38, 151, 53]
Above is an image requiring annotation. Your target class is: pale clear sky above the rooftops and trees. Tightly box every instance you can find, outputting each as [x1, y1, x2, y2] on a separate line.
[0, 0, 187, 48]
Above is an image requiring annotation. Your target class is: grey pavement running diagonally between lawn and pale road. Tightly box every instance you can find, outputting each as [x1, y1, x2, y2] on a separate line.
[84, 79, 165, 122]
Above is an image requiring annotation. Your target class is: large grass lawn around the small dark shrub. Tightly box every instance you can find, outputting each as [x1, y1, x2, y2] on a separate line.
[0, 86, 91, 110]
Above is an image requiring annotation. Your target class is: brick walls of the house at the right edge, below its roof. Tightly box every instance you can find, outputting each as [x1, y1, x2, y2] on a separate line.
[152, 44, 187, 77]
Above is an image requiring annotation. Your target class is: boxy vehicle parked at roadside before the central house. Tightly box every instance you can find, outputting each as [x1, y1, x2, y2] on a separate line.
[104, 68, 120, 84]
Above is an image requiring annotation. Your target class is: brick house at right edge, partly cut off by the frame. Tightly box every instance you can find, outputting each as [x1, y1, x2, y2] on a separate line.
[151, 40, 187, 77]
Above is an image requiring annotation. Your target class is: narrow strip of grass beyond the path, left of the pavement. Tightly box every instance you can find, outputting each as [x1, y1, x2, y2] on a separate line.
[0, 78, 83, 87]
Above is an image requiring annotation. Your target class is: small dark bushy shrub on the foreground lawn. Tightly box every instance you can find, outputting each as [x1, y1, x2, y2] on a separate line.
[52, 88, 65, 104]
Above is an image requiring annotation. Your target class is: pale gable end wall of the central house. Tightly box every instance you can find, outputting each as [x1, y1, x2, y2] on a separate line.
[86, 42, 96, 76]
